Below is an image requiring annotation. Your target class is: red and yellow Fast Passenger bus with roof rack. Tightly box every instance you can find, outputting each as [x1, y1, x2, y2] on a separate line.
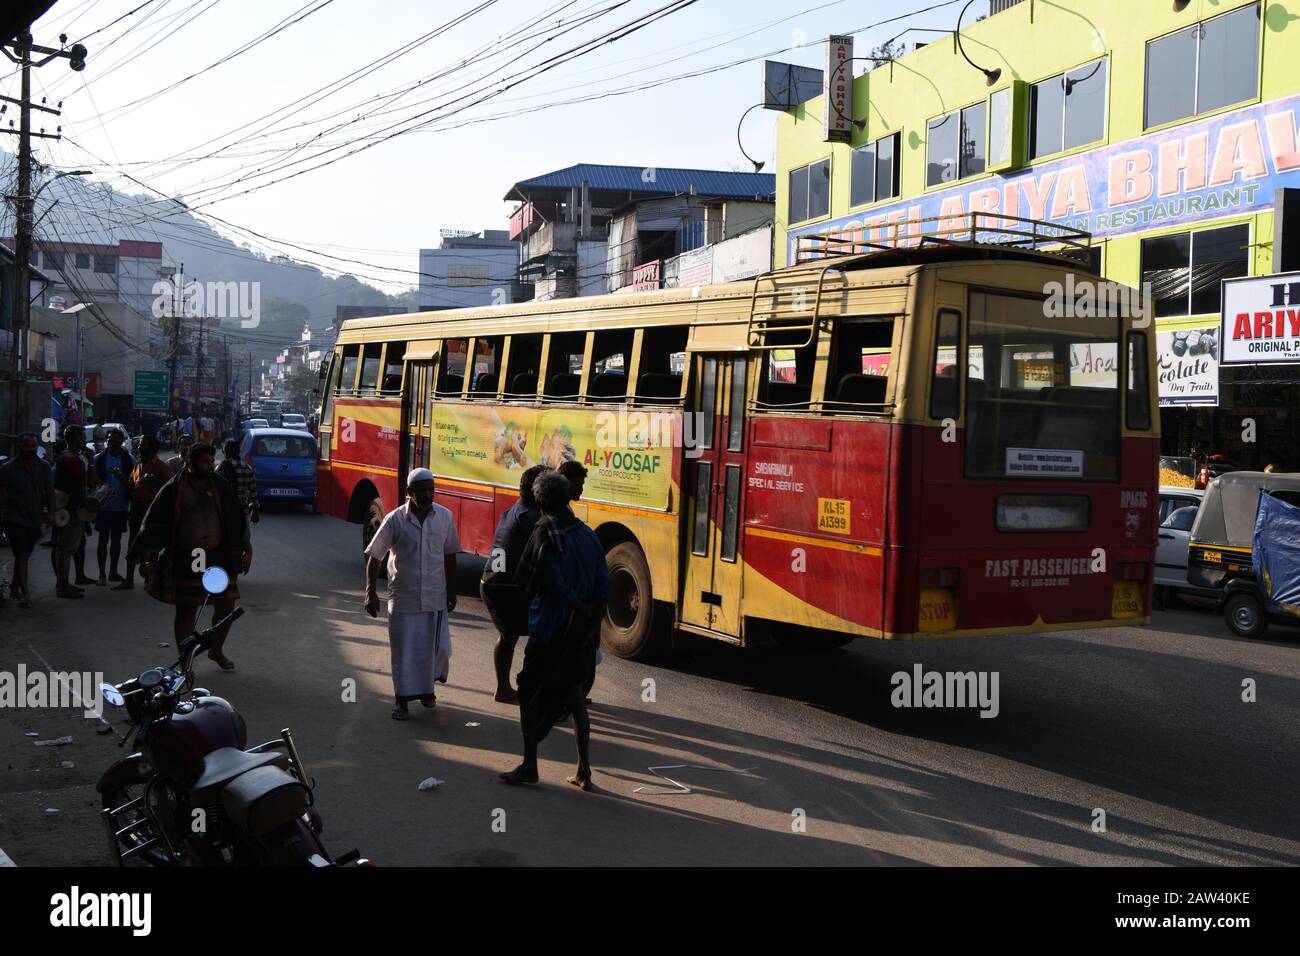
[319, 218, 1158, 658]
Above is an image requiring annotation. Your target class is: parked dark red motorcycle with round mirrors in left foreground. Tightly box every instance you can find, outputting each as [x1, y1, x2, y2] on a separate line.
[96, 567, 372, 866]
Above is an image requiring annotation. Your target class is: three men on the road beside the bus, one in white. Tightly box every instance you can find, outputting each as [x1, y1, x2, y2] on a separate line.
[364, 462, 610, 790]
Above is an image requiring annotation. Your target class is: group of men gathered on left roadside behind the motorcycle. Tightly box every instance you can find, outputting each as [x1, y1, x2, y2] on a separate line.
[0, 425, 257, 670]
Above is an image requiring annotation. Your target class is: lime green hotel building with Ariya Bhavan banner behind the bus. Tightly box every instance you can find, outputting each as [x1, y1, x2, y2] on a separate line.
[775, 0, 1300, 470]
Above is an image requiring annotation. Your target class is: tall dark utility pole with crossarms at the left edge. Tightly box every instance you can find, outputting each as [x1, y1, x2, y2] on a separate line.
[0, 30, 86, 453]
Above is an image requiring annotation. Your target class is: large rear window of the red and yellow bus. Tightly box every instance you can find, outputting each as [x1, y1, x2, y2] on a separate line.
[966, 293, 1119, 481]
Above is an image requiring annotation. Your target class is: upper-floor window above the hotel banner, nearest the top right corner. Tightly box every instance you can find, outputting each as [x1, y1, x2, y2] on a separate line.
[1145, 3, 1260, 127]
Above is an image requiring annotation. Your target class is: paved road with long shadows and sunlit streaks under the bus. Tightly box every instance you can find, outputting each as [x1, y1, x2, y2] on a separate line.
[0, 510, 1300, 865]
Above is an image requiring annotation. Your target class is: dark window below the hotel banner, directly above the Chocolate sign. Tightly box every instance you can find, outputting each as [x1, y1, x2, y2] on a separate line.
[1141, 224, 1251, 317]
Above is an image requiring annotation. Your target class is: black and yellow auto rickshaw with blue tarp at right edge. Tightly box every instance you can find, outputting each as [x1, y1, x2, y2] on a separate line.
[1187, 471, 1300, 637]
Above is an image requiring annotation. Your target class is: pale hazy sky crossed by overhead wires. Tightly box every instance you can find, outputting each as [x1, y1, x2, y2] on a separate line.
[10, 0, 967, 290]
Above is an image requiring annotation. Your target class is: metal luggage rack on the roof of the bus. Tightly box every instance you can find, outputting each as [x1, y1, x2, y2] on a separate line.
[792, 212, 1092, 268]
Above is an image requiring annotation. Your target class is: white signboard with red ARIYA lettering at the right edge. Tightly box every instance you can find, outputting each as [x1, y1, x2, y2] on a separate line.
[1219, 272, 1300, 365]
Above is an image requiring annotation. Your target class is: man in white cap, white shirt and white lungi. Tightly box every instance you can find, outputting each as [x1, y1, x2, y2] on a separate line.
[364, 468, 460, 721]
